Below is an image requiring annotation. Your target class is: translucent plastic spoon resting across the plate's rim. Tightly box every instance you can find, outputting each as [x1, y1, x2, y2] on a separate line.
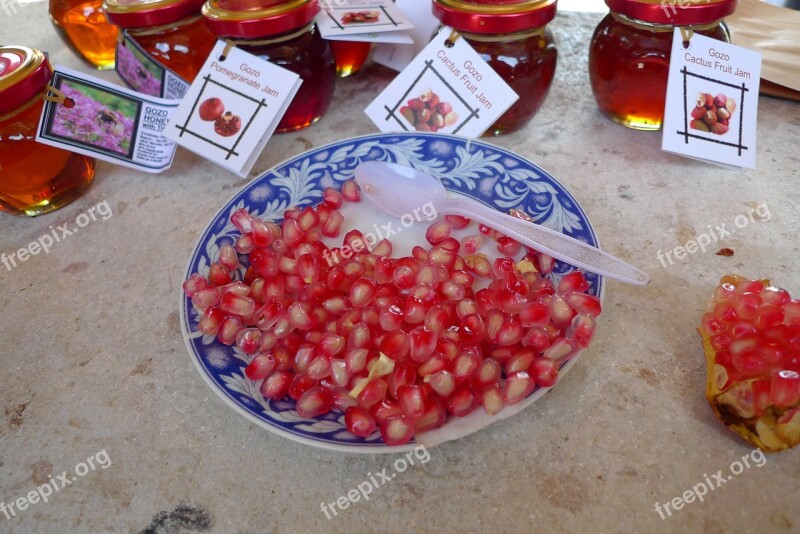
[355, 161, 650, 286]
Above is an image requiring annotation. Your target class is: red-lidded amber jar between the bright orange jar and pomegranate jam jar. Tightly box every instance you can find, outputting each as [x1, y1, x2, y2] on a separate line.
[105, 0, 217, 83]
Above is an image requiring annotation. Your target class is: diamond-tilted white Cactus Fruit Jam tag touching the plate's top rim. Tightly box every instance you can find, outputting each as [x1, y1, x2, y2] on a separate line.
[366, 28, 519, 137]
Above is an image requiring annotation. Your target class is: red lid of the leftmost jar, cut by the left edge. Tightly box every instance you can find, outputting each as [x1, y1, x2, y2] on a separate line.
[0, 46, 53, 115]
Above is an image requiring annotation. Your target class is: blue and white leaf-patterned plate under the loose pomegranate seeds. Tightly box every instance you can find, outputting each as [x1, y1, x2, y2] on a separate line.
[180, 133, 603, 454]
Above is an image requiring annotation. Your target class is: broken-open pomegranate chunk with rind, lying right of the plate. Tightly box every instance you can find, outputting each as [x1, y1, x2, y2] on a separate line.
[700, 275, 800, 451]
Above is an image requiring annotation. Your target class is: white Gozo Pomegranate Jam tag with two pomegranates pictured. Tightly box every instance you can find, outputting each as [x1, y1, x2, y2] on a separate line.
[164, 41, 302, 176]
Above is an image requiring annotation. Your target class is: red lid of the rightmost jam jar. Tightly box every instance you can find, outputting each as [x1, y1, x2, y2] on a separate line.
[606, 0, 736, 26]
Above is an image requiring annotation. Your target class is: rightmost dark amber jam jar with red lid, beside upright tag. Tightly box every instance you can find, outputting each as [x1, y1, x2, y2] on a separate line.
[589, 0, 736, 130]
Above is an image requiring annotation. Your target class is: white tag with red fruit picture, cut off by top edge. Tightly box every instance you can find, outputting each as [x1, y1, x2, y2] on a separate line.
[316, 0, 414, 39]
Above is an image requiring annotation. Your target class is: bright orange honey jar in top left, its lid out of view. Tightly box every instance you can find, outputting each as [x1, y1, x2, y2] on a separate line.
[50, 0, 117, 69]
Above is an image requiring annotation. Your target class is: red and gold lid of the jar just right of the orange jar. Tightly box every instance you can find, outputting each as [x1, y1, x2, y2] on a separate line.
[103, 0, 203, 28]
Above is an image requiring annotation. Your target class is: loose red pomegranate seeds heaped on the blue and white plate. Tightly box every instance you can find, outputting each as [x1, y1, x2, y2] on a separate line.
[183, 181, 600, 445]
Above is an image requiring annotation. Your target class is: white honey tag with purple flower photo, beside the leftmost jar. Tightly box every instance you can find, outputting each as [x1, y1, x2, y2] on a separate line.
[36, 66, 178, 173]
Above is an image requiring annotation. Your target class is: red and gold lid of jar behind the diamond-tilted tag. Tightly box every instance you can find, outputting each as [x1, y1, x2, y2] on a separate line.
[433, 0, 557, 34]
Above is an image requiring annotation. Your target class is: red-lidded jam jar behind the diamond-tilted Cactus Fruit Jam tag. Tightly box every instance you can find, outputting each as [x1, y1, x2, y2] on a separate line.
[433, 0, 558, 136]
